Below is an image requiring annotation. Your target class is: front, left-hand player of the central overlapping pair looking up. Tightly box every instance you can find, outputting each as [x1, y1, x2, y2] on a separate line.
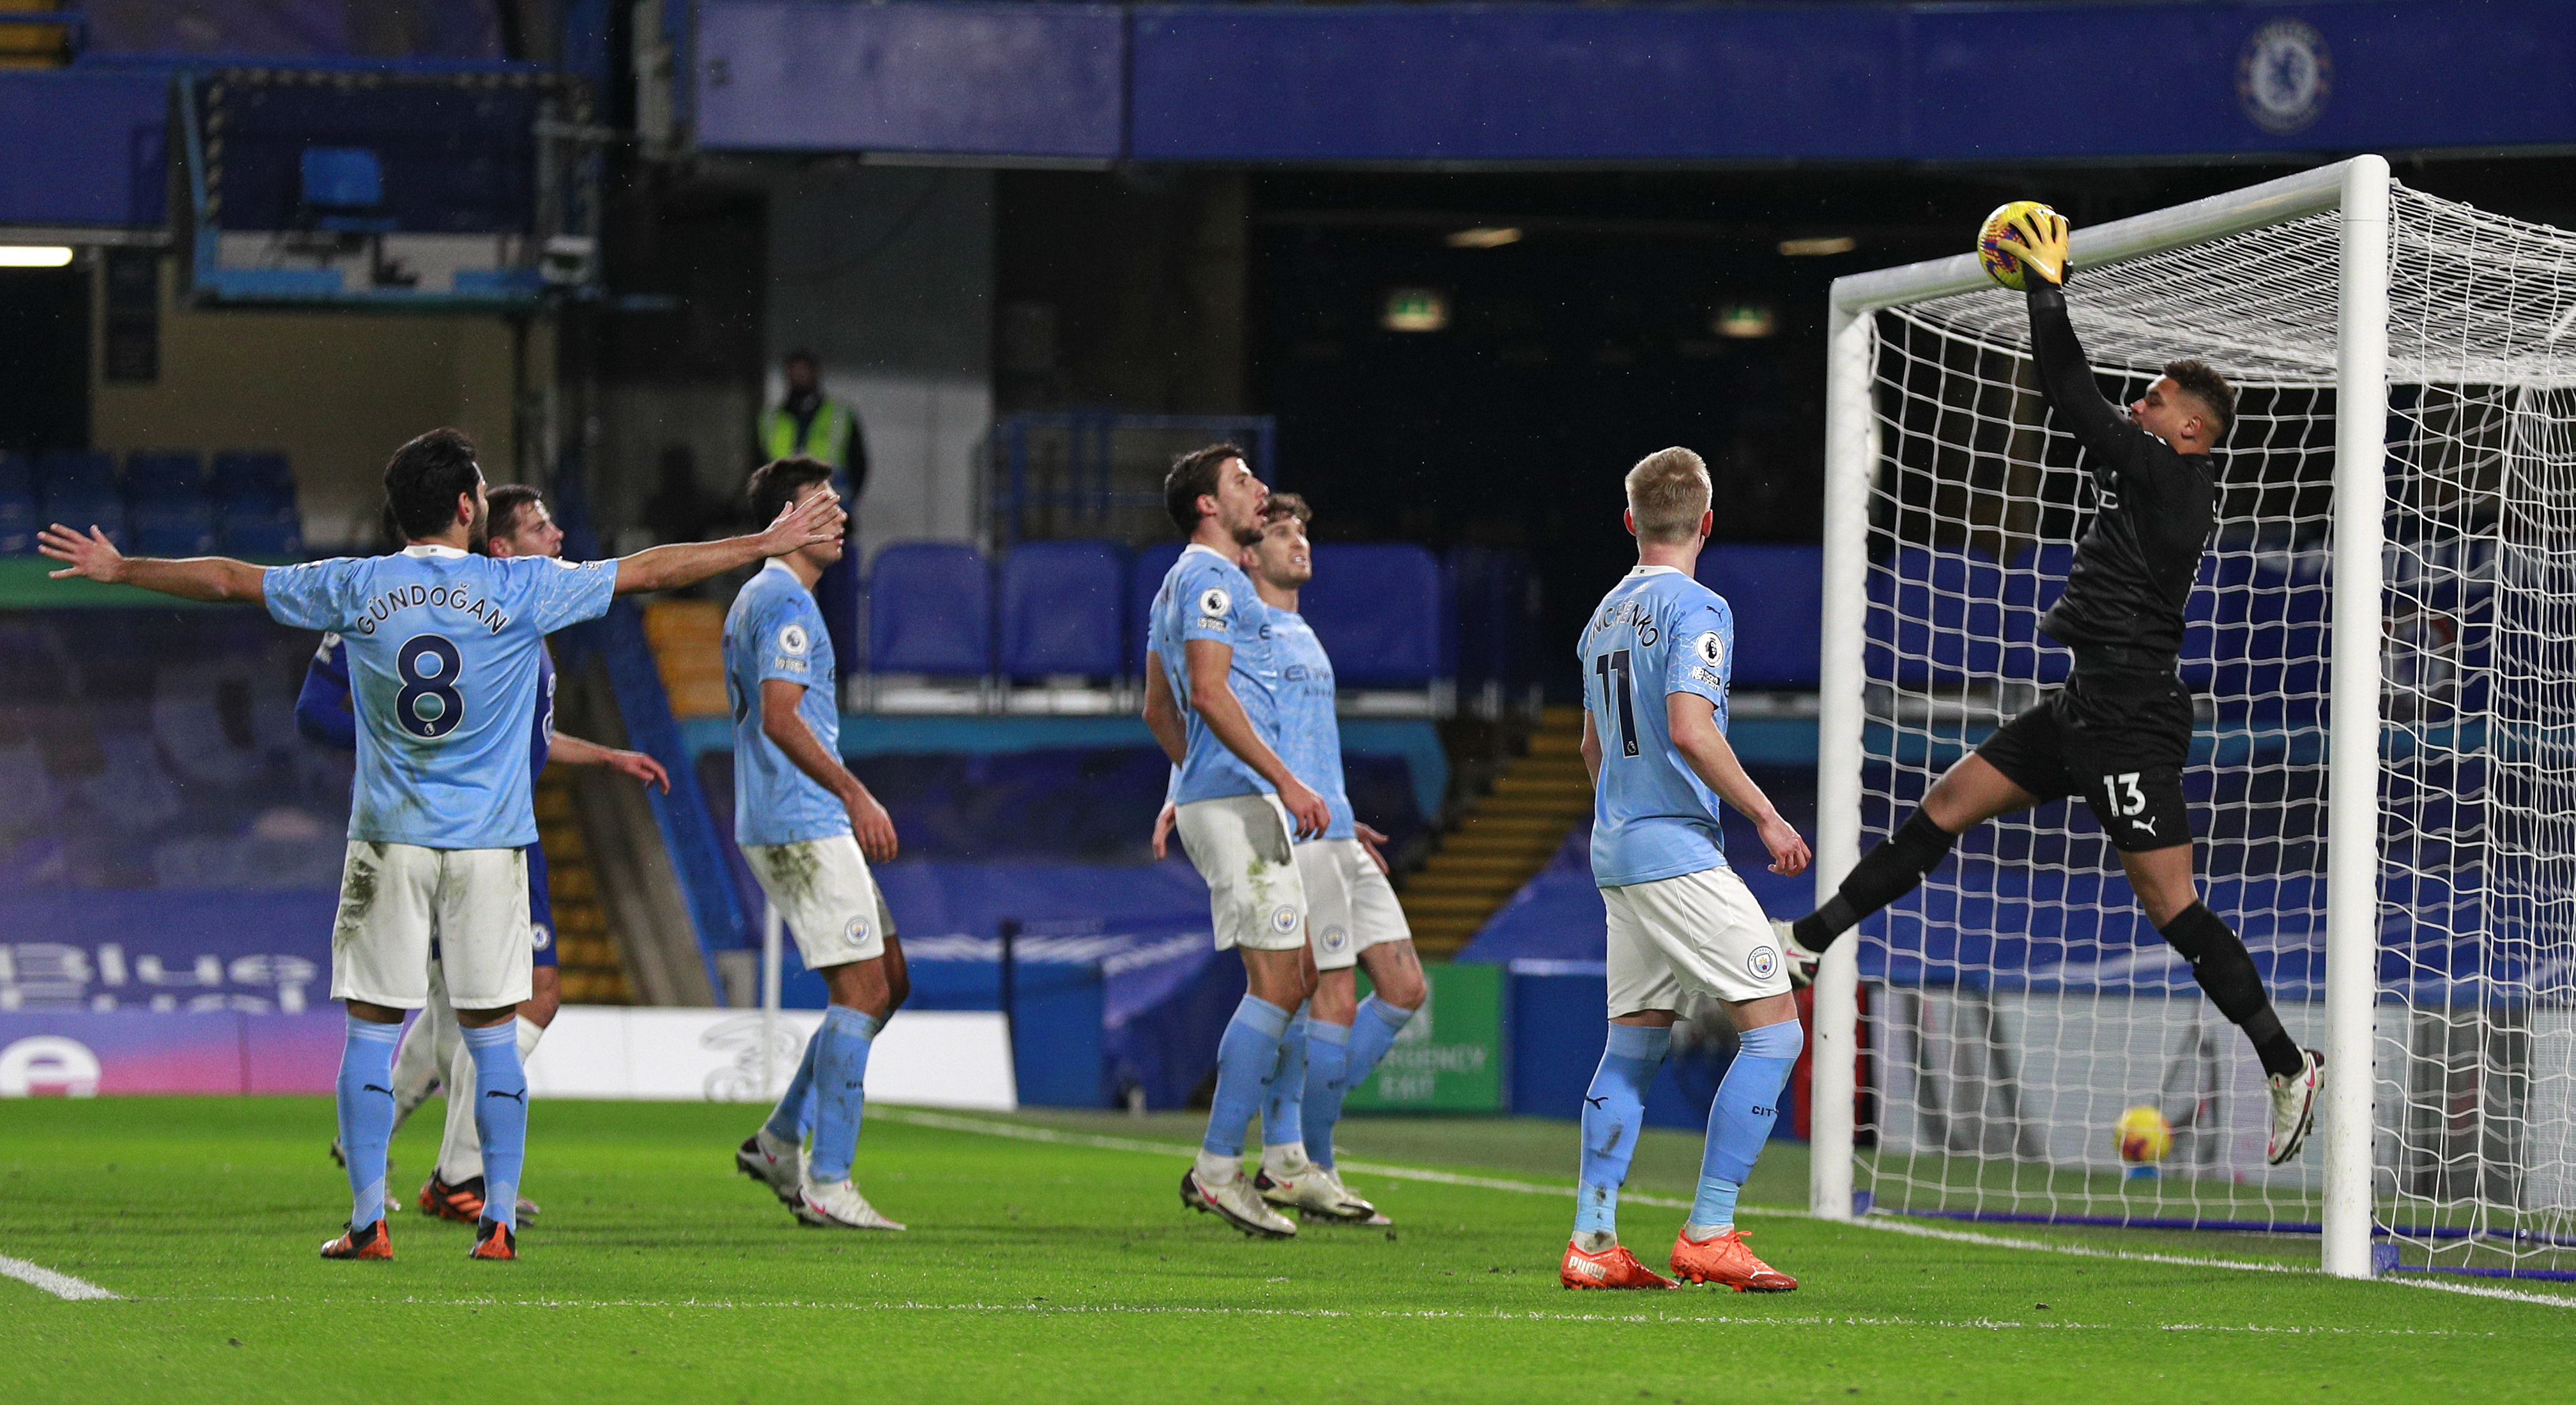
[1144, 443, 1332, 1240]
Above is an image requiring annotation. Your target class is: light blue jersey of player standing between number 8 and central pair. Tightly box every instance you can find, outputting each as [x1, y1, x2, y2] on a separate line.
[724, 562, 850, 843]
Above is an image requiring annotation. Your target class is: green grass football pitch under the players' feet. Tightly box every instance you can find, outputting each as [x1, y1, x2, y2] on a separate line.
[0, 1098, 2576, 1405]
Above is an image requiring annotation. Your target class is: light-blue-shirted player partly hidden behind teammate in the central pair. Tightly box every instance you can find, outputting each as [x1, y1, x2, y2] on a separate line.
[1154, 493, 1425, 1225]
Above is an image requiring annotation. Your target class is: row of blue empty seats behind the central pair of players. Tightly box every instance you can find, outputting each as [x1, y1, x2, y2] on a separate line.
[868, 541, 1463, 688]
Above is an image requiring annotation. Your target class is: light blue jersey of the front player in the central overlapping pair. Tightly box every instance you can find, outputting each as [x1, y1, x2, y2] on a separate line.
[1146, 541, 1280, 804]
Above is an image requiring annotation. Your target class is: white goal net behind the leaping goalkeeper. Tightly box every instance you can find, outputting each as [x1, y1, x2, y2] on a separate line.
[1819, 157, 2576, 1276]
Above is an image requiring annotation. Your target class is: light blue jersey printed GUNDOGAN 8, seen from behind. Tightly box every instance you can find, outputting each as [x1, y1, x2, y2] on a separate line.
[260, 546, 618, 848]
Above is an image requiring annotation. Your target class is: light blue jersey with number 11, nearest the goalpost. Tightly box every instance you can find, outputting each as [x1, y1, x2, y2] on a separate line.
[1579, 567, 1736, 887]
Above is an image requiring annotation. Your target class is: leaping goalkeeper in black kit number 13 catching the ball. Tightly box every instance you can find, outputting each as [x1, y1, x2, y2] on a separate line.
[1780, 211, 2328, 1165]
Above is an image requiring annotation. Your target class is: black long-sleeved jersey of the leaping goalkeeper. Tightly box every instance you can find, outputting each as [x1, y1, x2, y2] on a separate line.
[2030, 279, 2218, 668]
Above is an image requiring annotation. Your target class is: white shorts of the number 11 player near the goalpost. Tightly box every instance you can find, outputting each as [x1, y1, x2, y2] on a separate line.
[1602, 864, 1788, 1018]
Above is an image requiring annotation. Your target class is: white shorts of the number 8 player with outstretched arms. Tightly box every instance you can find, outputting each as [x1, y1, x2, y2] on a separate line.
[330, 840, 533, 1011]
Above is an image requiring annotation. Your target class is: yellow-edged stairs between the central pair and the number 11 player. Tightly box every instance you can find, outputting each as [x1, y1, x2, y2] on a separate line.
[1404, 707, 1592, 956]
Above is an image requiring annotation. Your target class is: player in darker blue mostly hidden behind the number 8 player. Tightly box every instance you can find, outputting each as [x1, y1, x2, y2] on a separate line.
[296, 482, 670, 1225]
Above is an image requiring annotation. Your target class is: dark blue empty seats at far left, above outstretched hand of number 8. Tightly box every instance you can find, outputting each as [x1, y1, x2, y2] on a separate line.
[0, 449, 304, 557]
